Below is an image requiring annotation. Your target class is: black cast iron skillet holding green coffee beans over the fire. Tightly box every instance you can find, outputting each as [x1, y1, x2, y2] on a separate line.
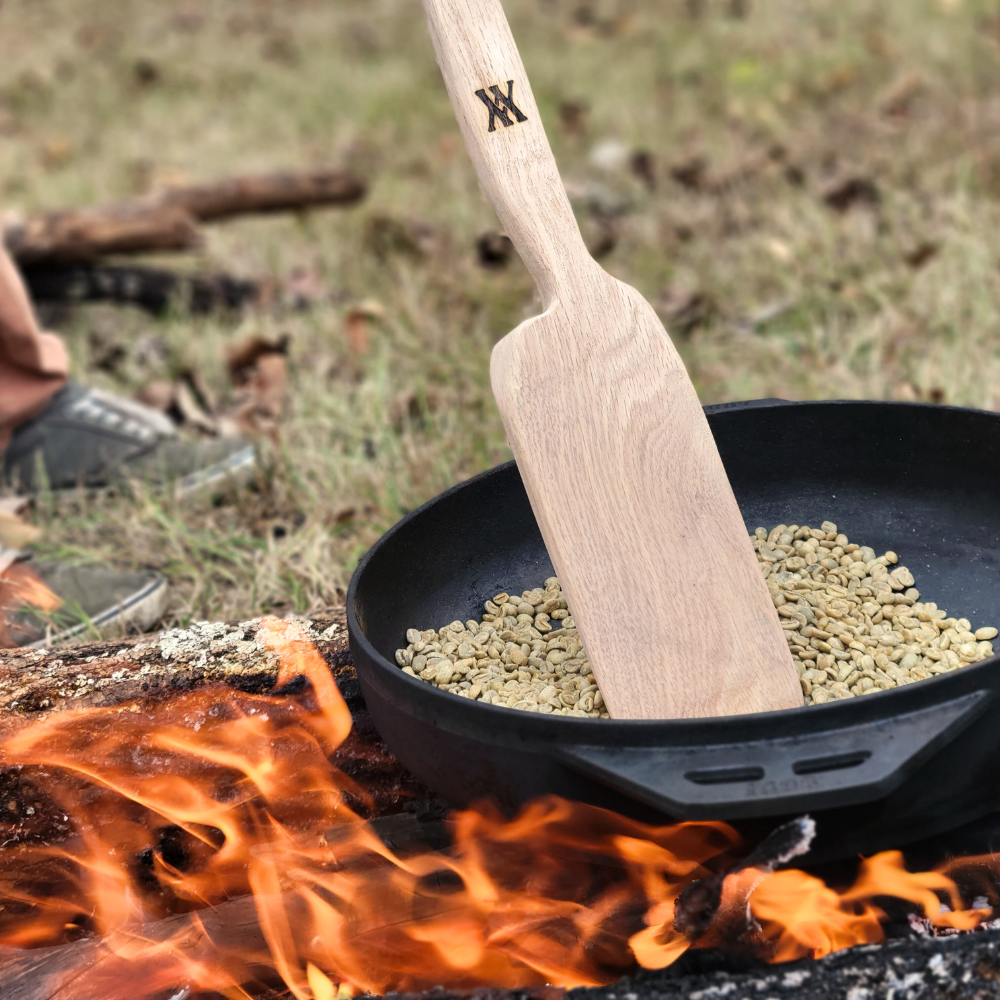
[347, 400, 1000, 859]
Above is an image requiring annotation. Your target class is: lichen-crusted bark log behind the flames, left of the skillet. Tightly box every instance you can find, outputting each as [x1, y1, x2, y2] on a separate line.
[0, 608, 434, 824]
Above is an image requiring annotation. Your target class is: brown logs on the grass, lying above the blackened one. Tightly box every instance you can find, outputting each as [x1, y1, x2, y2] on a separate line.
[3, 170, 367, 266]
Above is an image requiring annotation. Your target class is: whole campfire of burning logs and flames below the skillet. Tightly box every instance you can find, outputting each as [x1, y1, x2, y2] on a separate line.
[0, 609, 1000, 1000]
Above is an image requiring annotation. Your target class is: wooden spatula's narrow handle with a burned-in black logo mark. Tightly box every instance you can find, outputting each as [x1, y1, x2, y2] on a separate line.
[423, 0, 597, 307]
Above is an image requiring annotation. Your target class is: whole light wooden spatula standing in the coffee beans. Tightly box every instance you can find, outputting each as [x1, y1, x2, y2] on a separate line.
[424, 0, 802, 719]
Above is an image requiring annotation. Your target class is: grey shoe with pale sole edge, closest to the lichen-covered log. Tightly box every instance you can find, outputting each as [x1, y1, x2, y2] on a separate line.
[0, 549, 167, 647]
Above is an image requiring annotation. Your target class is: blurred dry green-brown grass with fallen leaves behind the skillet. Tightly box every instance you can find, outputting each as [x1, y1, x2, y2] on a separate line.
[0, 0, 1000, 623]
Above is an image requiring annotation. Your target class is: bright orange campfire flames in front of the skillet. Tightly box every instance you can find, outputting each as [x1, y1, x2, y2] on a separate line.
[0, 619, 992, 1000]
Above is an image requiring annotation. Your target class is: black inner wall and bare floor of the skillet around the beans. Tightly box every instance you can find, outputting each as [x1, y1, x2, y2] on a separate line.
[355, 401, 1000, 661]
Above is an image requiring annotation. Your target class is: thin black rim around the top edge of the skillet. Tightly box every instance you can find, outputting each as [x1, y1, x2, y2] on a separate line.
[347, 399, 1000, 746]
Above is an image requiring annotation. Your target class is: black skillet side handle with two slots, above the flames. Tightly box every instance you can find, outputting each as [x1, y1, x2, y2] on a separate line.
[557, 691, 992, 819]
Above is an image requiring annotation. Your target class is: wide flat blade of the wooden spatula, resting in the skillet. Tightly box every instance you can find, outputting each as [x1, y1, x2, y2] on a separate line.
[491, 265, 802, 719]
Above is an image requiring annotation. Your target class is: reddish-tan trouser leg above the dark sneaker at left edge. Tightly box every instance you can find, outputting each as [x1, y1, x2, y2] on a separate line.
[0, 243, 69, 451]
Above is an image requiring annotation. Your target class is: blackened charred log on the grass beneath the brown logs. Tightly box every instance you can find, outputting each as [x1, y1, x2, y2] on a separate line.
[22, 264, 259, 315]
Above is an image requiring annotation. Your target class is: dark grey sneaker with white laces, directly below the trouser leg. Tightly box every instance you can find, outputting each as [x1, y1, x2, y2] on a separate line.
[3, 382, 255, 493]
